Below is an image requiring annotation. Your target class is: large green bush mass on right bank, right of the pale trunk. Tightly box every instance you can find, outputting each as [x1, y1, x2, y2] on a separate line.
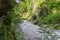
[33, 0, 60, 29]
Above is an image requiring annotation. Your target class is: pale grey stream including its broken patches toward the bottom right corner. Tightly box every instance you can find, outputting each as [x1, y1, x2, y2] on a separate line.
[20, 20, 60, 40]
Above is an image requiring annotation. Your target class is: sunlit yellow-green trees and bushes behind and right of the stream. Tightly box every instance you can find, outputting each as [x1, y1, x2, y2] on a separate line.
[22, 0, 60, 29]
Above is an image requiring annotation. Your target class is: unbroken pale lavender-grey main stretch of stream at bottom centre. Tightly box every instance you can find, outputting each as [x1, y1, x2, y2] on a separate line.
[21, 20, 40, 40]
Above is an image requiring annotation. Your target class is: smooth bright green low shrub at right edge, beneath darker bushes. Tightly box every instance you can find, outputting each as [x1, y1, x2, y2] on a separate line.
[45, 13, 60, 24]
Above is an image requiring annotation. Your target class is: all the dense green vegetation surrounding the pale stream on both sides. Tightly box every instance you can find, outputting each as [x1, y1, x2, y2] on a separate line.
[0, 0, 60, 40]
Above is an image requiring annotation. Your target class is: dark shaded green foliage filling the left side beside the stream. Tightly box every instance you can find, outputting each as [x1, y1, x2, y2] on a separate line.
[0, 0, 23, 40]
